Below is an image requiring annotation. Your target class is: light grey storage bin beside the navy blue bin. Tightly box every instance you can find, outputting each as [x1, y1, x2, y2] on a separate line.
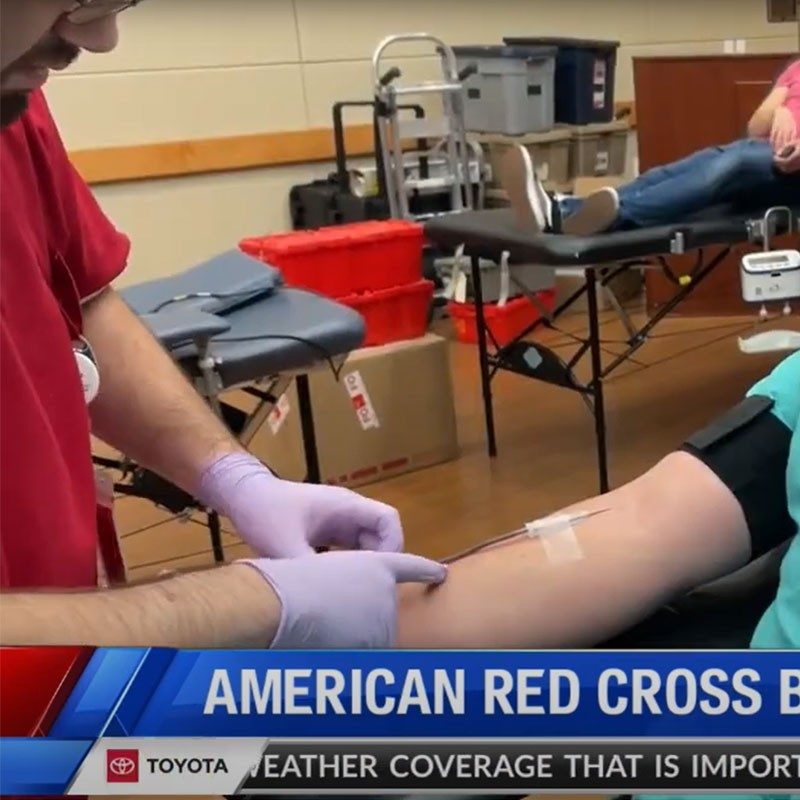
[453, 45, 558, 136]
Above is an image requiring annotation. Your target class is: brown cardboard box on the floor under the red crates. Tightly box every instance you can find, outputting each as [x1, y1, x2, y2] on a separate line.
[245, 334, 458, 487]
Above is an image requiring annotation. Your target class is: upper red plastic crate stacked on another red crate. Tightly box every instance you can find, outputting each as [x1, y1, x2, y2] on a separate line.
[239, 220, 423, 298]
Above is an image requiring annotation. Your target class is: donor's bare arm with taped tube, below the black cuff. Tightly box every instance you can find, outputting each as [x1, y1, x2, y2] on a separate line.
[398, 452, 751, 649]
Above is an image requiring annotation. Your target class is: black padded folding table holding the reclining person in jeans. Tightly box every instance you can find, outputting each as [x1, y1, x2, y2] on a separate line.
[426, 206, 800, 494]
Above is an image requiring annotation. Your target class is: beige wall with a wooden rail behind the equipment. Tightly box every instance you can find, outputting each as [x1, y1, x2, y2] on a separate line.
[48, 0, 798, 282]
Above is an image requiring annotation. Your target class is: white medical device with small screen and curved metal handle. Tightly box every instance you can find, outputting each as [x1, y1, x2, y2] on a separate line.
[741, 208, 800, 303]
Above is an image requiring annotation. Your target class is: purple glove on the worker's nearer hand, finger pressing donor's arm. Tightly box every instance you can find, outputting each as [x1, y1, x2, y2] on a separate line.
[243, 552, 447, 650]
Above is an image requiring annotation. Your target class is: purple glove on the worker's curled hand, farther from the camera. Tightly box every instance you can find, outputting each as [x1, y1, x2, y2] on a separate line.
[199, 453, 403, 558]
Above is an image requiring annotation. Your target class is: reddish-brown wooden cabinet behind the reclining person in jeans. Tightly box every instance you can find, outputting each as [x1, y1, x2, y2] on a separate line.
[634, 53, 797, 315]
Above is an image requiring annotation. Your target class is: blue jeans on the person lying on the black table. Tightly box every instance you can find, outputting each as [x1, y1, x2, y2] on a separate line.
[561, 139, 800, 228]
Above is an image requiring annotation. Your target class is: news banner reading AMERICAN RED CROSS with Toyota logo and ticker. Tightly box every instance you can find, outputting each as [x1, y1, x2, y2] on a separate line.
[0, 648, 800, 795]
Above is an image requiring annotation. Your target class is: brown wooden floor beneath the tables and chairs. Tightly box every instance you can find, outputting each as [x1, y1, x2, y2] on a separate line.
[117, 312, 800, 579]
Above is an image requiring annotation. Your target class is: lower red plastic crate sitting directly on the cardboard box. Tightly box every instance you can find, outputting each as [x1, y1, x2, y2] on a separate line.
[339, 281, 434, 347]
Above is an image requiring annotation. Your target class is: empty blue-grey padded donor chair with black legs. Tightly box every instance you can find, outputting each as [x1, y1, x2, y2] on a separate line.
[95, 250, 365, 562]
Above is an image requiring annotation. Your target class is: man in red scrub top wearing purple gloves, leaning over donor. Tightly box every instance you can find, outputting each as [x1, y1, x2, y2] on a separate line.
[0, 0, 445, 648]
